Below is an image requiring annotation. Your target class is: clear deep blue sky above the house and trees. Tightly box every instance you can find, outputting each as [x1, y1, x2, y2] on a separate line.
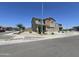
[0, 2, 79, 28]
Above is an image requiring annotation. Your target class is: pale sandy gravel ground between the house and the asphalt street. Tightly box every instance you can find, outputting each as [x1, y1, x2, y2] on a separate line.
[0, 32, 79, 45]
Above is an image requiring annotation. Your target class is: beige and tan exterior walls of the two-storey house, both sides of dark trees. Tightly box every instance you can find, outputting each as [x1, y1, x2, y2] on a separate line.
[32, 18, 59, 33]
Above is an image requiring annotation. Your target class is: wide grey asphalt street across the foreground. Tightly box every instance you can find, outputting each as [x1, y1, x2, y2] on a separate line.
[0, 36, 79, 57]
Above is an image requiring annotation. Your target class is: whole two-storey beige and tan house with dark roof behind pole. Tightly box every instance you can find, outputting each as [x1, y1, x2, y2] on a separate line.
[32, 17, 62, 33]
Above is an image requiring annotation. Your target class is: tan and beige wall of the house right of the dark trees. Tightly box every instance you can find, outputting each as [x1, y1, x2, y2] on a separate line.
[45, 19, 59, 32]
